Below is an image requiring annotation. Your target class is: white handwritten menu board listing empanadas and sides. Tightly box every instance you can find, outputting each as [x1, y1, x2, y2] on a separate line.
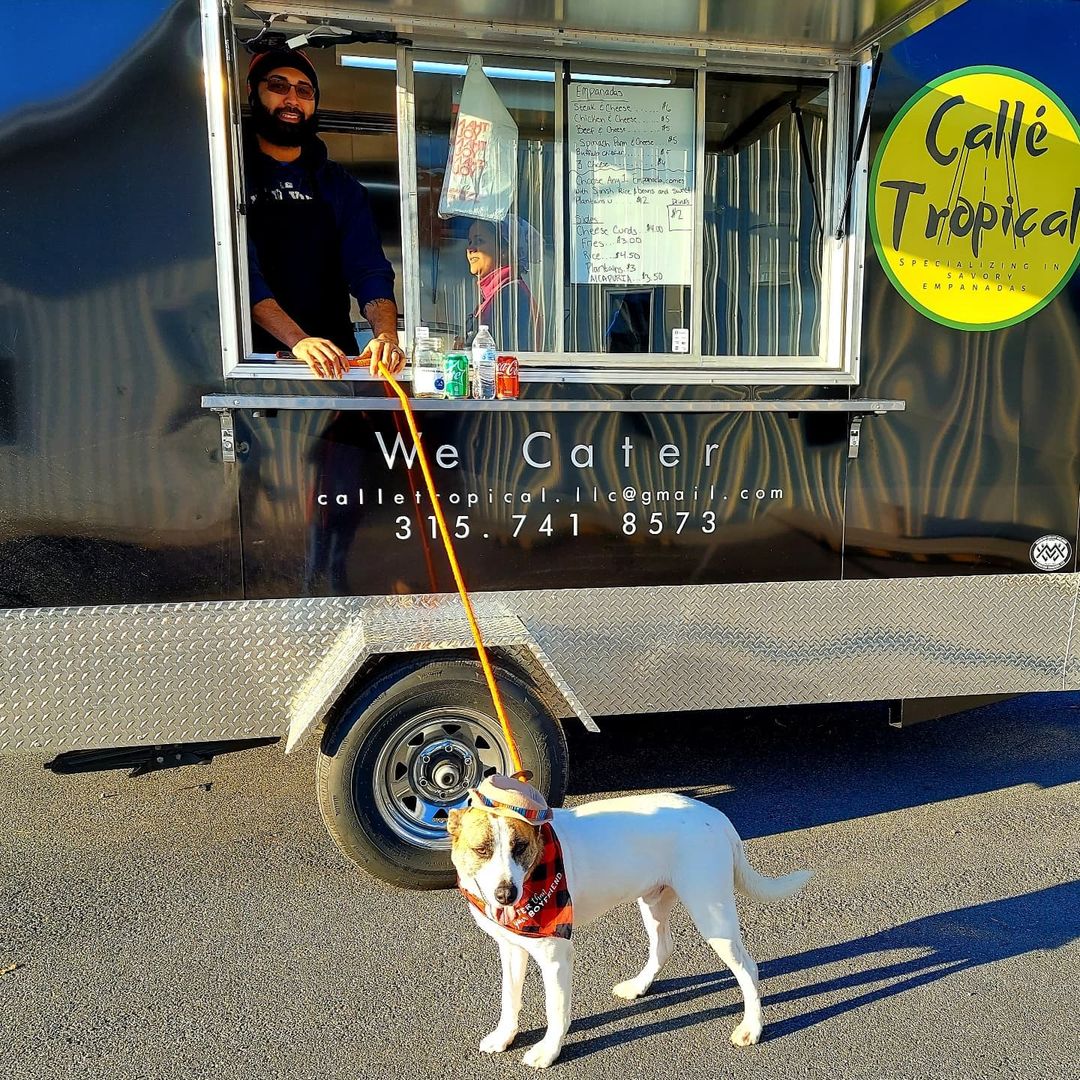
[567, 82, 694, 285]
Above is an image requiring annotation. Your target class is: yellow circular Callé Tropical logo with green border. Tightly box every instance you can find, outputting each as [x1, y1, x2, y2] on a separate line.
[869, 67, 1080, 330]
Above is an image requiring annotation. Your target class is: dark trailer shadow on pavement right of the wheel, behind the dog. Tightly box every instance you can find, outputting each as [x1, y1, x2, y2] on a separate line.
[567, 693, 1080, 838]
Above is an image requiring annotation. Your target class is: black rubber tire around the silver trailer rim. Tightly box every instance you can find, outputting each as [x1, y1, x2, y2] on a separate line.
[315, 658, 568, 889]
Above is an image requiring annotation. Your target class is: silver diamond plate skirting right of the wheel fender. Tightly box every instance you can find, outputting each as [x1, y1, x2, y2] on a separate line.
[502, 575, 1080, 716]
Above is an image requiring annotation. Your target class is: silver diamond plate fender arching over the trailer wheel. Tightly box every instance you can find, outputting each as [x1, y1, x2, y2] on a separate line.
[285, 595, 599, 754]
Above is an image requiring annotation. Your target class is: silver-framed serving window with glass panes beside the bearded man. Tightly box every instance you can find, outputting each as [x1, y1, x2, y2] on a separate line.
[212, 2, 861, 383]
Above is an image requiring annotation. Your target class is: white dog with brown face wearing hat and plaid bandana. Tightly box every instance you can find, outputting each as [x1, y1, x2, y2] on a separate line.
[448, 777, 811, 1068]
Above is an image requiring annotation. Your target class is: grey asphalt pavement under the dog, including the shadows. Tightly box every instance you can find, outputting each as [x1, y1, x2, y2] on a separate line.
[0, 694, 1080, 1080]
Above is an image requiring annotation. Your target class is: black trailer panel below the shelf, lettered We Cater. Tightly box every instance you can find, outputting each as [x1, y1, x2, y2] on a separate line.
[237, 403, 851, 599]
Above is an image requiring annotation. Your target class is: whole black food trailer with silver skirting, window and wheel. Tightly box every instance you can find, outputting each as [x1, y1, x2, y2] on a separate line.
[0, 0, 1080, 888]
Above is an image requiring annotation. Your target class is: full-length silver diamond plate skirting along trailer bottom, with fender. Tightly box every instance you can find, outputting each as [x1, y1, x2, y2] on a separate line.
[0, 573, 1080, 750]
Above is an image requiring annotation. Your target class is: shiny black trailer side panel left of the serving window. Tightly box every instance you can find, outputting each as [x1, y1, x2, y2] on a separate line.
[0, 0, 241, 607]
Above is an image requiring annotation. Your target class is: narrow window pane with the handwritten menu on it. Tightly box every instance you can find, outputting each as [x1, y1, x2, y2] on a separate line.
[566, 62, 698, 364]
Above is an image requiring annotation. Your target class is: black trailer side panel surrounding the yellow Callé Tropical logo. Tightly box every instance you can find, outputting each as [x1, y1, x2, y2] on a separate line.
[845, 0, 1080, 578]
